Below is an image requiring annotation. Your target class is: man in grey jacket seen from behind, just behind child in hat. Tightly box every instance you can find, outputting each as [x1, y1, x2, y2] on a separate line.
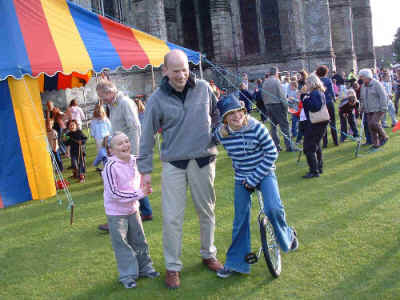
[261, 67, 293, 152]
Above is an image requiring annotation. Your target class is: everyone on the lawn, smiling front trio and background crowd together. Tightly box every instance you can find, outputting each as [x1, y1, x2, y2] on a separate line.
[42, 50, 400, 289]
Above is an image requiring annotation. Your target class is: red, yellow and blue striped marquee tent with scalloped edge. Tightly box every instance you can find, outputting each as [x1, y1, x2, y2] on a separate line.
[0, 0, 200, 208]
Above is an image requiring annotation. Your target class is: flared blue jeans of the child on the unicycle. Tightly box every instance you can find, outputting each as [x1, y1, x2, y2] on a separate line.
[225, 171, 294, 273]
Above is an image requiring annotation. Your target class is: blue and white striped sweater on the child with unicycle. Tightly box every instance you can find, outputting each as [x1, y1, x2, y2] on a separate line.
[214, 116, 278, 187]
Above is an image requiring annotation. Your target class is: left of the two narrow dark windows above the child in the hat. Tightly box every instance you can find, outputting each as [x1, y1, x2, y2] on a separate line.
[240, 0, 260, 55]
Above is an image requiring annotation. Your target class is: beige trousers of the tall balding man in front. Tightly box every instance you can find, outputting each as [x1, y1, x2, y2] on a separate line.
[161, 160, 217, 271]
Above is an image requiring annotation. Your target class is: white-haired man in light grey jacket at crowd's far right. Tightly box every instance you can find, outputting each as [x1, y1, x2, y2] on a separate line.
[359, 69, 389, 149]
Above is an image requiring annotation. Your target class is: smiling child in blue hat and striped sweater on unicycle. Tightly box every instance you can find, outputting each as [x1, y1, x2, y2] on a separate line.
[214, 95, 299, 278]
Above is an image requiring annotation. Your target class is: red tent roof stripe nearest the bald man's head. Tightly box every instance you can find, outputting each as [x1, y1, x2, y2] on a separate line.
[99, 16, 150, 69]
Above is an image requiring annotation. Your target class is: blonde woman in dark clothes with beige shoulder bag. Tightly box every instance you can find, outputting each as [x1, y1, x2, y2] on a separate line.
[302, 74, 329, 179]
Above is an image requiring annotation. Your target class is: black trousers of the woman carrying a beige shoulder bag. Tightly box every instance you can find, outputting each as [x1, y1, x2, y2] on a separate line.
[303, 122, 328, 174]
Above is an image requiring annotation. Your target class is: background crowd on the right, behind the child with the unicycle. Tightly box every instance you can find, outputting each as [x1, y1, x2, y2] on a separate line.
[231, 66, 400, 178]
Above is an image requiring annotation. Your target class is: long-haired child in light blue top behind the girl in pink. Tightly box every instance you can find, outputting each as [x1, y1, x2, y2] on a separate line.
[90, 104, 111, 153]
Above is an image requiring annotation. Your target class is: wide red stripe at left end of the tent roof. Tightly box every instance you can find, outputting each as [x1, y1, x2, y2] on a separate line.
[14, 0, 62, 76]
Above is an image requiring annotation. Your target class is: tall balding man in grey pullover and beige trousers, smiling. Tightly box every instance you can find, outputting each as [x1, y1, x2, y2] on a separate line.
[138, 50, 222, 288]
